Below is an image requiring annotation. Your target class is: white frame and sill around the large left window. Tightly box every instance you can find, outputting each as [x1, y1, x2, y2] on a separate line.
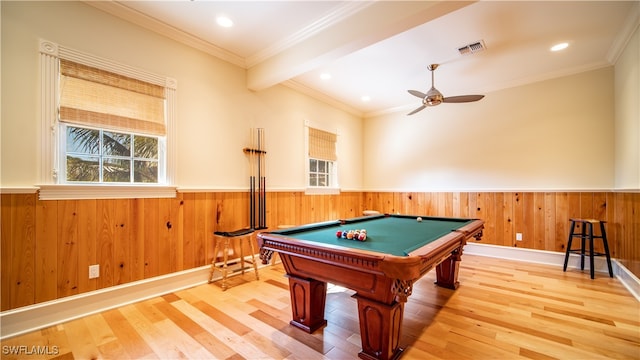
[38, 39, 177, 200]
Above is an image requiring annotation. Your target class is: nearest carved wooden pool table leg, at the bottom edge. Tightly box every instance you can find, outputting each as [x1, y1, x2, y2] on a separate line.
[353, 294, 404, 360]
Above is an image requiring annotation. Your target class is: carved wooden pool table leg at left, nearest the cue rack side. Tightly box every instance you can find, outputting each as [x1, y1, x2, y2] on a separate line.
[287, 275, 327, 333]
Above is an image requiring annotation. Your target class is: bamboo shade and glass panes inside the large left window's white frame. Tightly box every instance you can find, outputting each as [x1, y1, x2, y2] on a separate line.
[58, 59, 166, 184]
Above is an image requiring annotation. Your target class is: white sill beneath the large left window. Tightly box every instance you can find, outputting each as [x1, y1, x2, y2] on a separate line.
[39, 185, 176, 200]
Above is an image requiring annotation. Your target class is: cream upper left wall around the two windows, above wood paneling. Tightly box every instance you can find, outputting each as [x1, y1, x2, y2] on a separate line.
[0, 1, 362, 190]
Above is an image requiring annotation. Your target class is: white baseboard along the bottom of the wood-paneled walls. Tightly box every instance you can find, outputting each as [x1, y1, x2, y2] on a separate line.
[0, 243, 640, 339]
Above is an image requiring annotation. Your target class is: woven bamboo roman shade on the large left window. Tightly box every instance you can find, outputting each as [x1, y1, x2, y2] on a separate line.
[60, 59, 166, 136]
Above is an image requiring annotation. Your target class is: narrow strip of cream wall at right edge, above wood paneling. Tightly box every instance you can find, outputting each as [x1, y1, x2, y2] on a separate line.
[615, 24, 640, 190]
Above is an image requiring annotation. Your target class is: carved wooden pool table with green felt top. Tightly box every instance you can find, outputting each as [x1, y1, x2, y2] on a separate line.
[257, 214, 484, 360]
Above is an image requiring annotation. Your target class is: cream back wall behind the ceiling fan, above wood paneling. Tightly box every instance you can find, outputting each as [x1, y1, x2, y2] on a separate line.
[364, 67, 614, 191]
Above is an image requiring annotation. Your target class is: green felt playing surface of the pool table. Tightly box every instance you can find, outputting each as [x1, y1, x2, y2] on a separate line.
[272, 215, 473, 256]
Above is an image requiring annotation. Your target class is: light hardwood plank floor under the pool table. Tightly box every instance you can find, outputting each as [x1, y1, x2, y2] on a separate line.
[2, 255, 640, 360]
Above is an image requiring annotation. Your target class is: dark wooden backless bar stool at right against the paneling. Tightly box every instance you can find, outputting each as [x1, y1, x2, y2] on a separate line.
[562, 219, 613, 279]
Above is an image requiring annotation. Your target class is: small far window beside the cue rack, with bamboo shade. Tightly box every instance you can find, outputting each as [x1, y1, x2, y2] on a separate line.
[307, 127, 338, 189]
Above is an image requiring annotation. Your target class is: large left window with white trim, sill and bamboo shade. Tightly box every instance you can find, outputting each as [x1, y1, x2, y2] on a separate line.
[40, 40, 176, 199]
